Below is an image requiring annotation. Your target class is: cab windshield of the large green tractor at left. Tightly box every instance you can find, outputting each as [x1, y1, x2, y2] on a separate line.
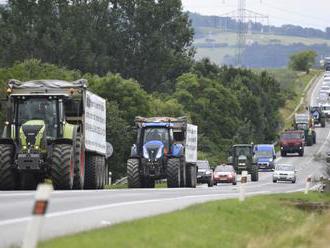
[17, 98, 58, 138]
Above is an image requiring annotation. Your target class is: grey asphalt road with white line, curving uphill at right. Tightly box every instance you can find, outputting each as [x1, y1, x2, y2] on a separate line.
[0, 74, 324, 247]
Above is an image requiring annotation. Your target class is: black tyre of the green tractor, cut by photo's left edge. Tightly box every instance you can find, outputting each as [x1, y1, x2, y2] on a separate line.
[0, 144, 17, 190]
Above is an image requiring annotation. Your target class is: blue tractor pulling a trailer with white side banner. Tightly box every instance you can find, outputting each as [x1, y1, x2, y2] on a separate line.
[127, 117, 197, 188]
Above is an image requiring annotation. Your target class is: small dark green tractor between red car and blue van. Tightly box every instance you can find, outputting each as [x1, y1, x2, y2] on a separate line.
[228, 144, 259, 182]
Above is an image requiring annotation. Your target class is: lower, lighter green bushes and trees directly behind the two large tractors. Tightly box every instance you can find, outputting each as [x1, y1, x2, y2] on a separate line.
[0, 60, 283, 178]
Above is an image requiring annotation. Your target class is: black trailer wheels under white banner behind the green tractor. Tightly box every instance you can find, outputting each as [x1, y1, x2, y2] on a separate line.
[84, 153, 101, 189]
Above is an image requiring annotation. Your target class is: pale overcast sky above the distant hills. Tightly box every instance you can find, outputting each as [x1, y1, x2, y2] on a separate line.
[182, 0, 330, 30]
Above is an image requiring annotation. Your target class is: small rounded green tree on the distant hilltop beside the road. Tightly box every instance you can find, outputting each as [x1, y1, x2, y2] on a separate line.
[289, 50, 317, 73]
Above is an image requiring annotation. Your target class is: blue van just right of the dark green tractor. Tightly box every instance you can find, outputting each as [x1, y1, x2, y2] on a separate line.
[254, 144, 276, 170]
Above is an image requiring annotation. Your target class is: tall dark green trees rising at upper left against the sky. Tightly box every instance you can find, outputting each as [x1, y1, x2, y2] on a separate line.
[0, 0, 193, 91]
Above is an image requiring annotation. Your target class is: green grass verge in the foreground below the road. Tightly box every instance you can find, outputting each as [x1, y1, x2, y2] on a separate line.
[39, 193, 330, 248]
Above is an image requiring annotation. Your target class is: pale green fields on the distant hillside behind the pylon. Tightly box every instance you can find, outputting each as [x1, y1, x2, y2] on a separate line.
[194, 28, 330, 64]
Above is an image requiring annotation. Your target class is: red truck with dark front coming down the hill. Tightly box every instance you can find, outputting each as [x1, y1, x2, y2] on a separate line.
[279, 130, 305, 157]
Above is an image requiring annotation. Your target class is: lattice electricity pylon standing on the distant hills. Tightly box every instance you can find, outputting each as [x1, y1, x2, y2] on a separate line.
[221, 0, 269, 66]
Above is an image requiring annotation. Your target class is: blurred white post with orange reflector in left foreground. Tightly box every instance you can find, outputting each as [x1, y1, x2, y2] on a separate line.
[22, 183, 53, 248]
